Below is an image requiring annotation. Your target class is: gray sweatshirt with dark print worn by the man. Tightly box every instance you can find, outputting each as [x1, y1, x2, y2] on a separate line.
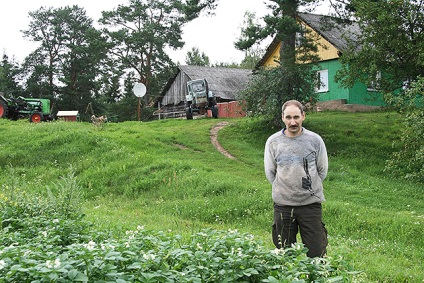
[264, 128, 328, 206]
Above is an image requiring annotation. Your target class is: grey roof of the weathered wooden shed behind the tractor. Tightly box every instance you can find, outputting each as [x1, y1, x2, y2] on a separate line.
[162, 65, 252, 100]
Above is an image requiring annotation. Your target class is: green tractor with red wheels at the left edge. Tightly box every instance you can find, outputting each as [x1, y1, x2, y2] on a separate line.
[0, 94, 53, 123]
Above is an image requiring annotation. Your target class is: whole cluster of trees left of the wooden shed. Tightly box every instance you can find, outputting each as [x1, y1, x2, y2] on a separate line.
[0, 0, 222, 121]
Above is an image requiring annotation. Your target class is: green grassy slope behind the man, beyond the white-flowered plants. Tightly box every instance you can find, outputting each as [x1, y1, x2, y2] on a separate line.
[0, 112, 424, 282]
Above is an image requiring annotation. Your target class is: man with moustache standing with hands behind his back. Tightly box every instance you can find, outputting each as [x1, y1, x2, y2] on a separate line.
[264, 100, 328, 257]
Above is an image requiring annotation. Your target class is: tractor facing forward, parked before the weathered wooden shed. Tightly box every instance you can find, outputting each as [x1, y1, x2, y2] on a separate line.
[186, 79, 218, 120]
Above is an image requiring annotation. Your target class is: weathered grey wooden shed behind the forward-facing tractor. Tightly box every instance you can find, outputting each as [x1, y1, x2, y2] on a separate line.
[160, 65, 252, 115]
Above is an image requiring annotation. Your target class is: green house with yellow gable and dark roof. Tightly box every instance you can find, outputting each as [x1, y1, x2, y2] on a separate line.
[256, 13, 385, 111]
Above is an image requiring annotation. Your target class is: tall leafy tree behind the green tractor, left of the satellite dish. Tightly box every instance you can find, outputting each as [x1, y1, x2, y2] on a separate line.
[23, 6, 105, 110]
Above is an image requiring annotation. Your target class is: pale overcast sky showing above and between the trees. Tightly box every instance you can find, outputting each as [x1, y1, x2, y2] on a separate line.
[0, 0, 327, 64]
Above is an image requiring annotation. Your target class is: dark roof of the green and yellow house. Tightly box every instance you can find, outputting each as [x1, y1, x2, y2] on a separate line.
[255, 13, 360, 69]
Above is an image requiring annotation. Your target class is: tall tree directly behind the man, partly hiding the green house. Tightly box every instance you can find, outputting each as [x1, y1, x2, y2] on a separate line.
[235, 0, 318, 124]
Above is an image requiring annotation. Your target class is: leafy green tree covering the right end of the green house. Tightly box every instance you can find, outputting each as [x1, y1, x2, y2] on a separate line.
[336, 0, 424, 93]
